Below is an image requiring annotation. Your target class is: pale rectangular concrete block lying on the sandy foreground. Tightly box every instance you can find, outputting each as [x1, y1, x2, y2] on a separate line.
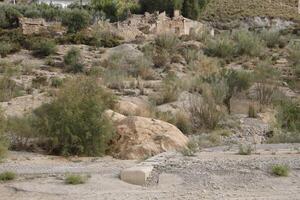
[121, 166, 153, 186]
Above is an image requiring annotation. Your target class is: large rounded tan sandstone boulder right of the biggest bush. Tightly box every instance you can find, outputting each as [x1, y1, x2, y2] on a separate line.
[112, 116, 188, 159]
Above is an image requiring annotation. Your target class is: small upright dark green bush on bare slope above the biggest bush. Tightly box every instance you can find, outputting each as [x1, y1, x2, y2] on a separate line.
[64, 47, 84, 73]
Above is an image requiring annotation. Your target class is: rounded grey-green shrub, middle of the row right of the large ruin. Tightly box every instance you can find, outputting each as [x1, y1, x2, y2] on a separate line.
[234, 30, 264, 56]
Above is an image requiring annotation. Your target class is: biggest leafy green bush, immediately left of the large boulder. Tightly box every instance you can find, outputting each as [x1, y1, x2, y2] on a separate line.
[34, 77, 115, 156]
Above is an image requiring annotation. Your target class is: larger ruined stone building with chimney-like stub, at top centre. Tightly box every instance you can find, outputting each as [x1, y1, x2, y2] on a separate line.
[114, 10, 204, 40]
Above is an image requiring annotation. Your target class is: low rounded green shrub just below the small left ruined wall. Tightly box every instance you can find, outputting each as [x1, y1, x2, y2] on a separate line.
[32, 39, 57, 57]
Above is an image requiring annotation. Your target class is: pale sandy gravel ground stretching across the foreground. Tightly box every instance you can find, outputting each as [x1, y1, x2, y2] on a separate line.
[0, 144, 300, 200]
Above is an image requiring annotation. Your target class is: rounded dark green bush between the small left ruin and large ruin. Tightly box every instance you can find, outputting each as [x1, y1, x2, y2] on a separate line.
[62, 9, 91, 33]
